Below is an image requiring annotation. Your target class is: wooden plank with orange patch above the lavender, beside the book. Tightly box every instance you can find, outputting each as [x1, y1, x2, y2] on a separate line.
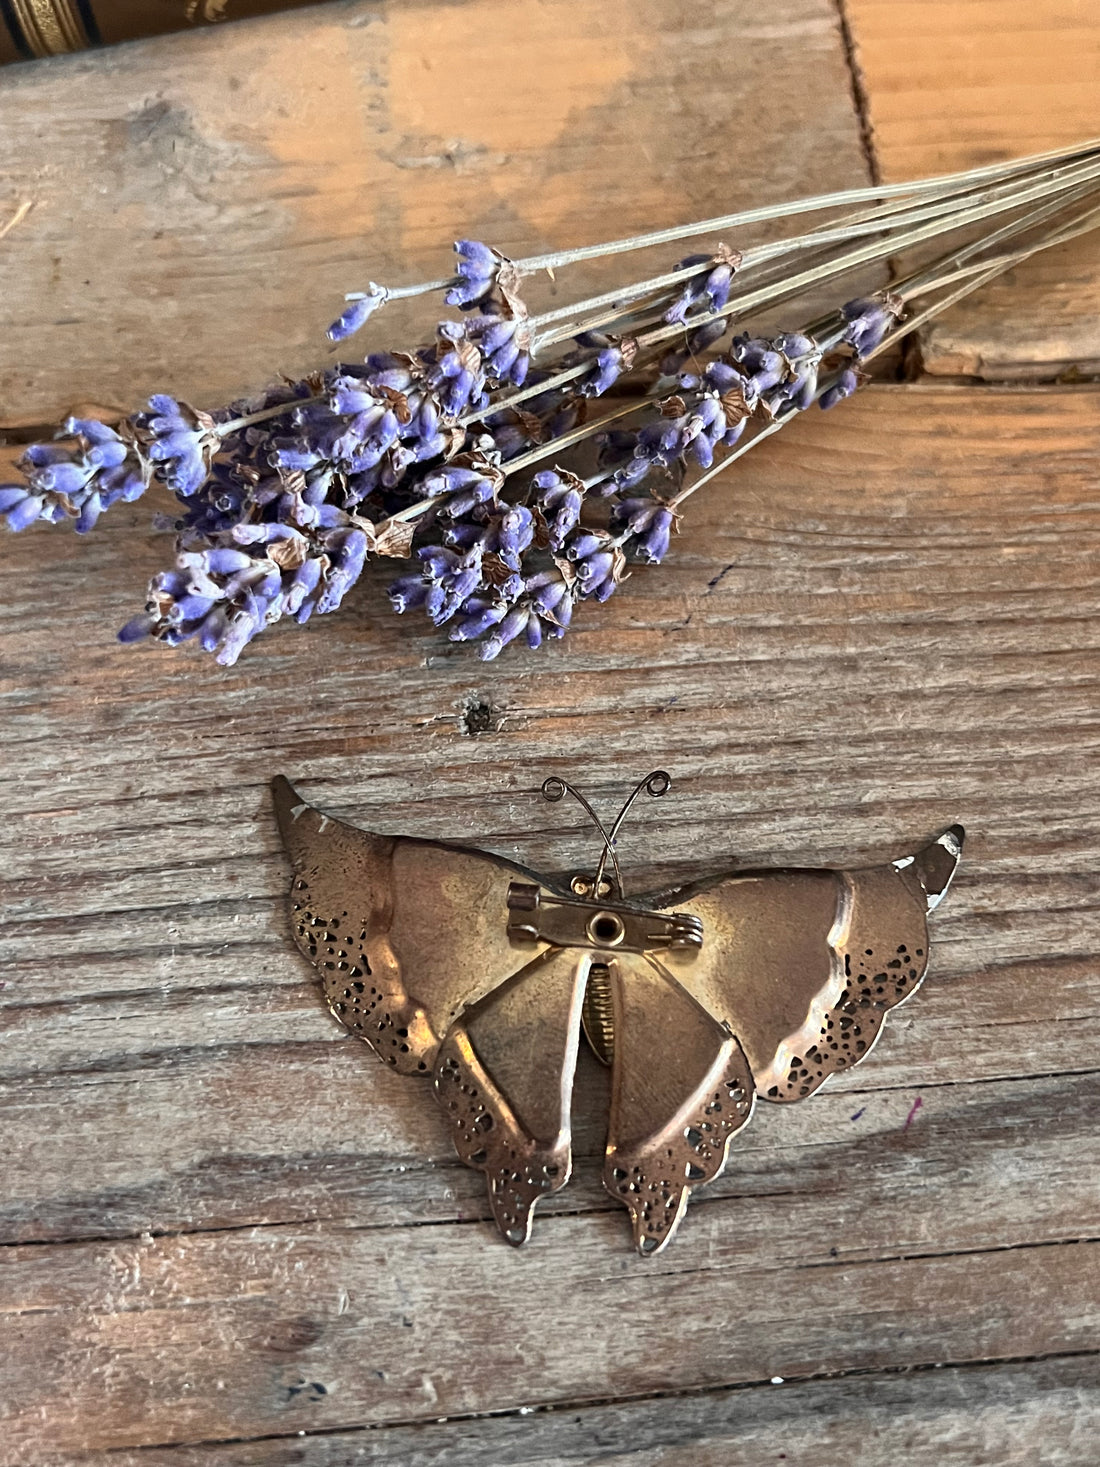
[0, 0, 867, 425]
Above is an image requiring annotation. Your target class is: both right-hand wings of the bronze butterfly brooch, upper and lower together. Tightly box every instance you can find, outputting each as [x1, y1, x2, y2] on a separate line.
[604, 826, 964, 1254]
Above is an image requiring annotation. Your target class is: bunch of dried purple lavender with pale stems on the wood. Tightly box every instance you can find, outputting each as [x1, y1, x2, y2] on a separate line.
[0, 137, 1100, 666]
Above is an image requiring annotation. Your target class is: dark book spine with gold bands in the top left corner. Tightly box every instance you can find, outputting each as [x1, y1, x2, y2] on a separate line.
[0, 0, 322, 63]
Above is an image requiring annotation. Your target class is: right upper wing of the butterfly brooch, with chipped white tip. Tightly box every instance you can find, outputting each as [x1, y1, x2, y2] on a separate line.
[654, 826, 964, 1100]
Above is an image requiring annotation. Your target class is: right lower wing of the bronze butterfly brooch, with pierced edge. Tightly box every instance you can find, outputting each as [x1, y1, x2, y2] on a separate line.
[604, 954, 752, 1254]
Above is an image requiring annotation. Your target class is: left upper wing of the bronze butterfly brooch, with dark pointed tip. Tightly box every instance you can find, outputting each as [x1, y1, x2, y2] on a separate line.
[273, 776, 546, 1074]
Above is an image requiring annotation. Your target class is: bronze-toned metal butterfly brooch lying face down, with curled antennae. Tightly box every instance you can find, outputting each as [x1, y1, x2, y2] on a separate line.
[274, 770, 964, 1254]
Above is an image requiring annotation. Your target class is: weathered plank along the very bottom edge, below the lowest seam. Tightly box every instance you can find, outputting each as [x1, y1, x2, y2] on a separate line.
[66, 1358, 1100, 1467]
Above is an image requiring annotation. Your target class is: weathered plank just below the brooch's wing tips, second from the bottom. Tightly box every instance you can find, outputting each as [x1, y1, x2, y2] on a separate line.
[0, 1226, 1100, 1461]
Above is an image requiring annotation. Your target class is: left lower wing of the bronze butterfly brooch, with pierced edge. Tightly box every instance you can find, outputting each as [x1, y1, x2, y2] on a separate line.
[436, 948, 590, 1244]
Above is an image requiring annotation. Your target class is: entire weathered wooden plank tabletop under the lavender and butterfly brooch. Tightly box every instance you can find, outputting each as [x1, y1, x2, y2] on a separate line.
[0, 0, 1100, 1467]
